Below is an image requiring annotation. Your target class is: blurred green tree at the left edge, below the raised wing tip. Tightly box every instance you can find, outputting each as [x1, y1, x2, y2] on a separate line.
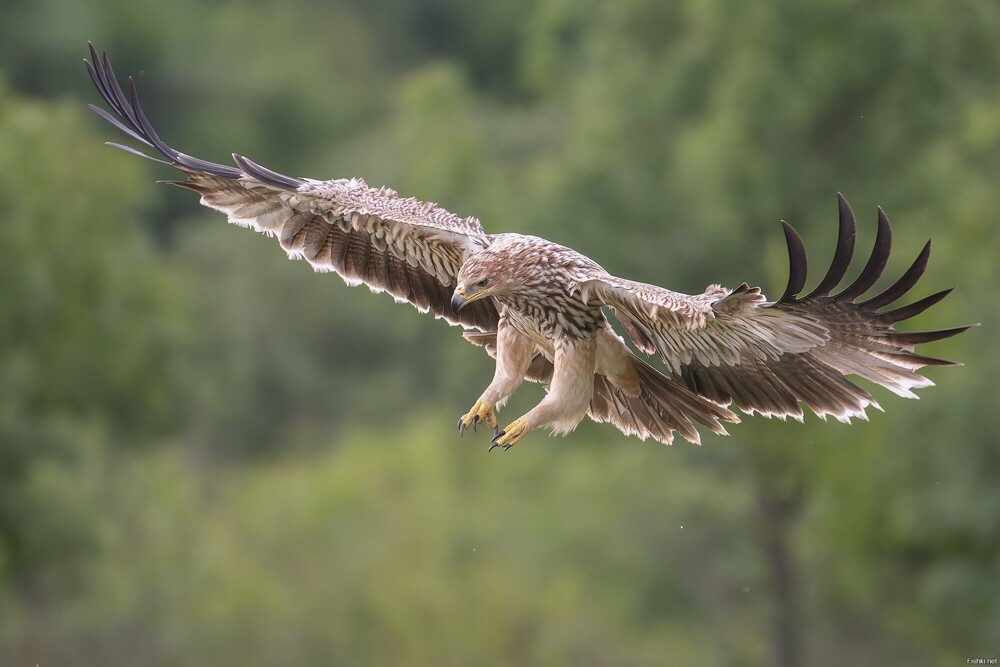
[0, 78, 185, 592]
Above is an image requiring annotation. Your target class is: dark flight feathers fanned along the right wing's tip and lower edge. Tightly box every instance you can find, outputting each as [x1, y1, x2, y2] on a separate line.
[681, 195, 968, 420]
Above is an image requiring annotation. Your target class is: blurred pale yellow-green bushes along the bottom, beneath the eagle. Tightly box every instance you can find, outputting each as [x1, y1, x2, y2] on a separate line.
[17, 417, 761, 665]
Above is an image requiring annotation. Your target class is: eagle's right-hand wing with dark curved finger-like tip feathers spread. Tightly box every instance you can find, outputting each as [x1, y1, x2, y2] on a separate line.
[574, 195, 968, 421]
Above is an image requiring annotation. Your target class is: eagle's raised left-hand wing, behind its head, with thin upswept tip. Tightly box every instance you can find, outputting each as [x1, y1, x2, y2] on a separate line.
[84, 44, 499, 331]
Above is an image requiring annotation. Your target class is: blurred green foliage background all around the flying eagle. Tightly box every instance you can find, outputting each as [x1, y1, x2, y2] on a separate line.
[0, 0, 1000, 667]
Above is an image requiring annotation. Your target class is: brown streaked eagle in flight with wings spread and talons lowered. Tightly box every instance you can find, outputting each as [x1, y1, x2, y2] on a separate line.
[84, 44, 968, 450]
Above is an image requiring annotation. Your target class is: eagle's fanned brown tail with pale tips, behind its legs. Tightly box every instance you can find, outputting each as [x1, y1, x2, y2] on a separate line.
[587, 354, 740, 445]
